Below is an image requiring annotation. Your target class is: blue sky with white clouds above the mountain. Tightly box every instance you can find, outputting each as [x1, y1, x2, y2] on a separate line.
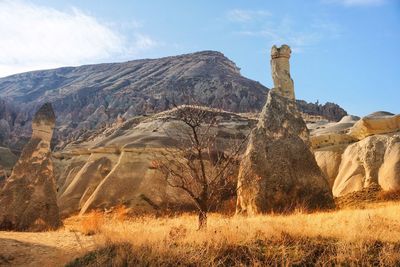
[0, 0, 400, 116]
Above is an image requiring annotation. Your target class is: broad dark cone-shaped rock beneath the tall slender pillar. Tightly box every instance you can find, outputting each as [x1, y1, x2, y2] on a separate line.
[237, 91, 333, 215]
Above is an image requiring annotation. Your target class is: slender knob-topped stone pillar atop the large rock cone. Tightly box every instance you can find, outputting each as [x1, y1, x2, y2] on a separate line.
[271, 44, 295, 100]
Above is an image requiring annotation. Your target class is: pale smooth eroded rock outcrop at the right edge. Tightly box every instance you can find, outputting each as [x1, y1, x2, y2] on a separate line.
[309, 112, 400, 197]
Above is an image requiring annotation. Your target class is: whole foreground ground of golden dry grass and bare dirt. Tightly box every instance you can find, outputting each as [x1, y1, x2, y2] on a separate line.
[0, 202, 400, 266]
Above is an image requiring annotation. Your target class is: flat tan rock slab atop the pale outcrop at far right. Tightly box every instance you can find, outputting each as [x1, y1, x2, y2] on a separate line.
[349, 113, 400, 140]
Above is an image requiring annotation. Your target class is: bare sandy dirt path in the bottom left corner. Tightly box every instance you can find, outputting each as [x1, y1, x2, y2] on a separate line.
[0, 230, 95, 267]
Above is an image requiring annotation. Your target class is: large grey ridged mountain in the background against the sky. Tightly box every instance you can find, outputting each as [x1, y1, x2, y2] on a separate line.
[0, 51, 347, 150]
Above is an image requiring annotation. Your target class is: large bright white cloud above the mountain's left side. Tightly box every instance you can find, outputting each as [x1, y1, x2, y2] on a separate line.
[0, 0, 157, 77]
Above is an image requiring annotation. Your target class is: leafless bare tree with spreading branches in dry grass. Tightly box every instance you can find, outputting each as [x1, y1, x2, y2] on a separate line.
[154, 106, 248, 229]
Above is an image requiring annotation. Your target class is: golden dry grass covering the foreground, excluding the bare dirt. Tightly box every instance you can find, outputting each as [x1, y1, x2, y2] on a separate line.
[67, 202, 400, 266]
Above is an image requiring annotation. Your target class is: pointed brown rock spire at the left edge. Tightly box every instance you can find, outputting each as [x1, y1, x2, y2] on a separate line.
[0, 103, 61, 231]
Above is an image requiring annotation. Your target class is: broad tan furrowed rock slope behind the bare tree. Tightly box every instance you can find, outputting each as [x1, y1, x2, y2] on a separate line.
[55, 106, 256, 216]
